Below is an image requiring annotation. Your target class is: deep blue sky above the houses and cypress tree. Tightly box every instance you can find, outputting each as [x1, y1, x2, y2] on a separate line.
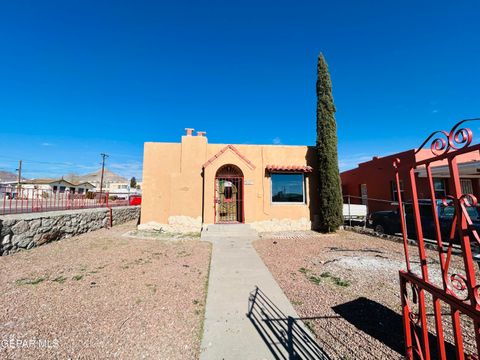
[0, 0, 480, 178]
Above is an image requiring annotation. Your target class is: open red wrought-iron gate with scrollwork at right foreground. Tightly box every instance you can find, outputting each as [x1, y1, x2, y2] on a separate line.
[394, 119, 480, 360]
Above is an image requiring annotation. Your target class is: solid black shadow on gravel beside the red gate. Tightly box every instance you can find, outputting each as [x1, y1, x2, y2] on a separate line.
[332, 297, 455, 359]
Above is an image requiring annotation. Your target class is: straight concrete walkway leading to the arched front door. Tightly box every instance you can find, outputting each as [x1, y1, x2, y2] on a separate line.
[200, 224, 326, 360]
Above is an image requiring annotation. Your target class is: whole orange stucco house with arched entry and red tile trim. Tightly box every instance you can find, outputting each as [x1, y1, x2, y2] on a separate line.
[141, 129, 317, 231]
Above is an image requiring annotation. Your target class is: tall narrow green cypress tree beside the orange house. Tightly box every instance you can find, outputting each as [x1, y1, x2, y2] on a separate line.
[317, 53, 343, 232]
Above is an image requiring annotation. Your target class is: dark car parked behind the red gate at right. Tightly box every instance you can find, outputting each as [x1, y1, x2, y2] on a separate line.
[368, 199, 480, 240]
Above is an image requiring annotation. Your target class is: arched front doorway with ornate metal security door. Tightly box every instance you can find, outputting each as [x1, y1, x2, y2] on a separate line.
[214, 164, 244, 224]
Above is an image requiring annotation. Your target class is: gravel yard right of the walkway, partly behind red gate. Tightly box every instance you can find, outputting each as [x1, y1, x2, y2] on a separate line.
[254, 231, 474, 359]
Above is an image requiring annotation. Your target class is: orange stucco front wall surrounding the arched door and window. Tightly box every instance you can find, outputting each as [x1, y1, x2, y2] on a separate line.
[141, 132, 317, 228]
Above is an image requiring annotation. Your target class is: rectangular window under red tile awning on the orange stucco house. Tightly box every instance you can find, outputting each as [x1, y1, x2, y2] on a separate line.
[271, 173, 305, 204]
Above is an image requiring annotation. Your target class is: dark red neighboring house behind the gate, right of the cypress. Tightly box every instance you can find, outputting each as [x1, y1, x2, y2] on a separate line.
[340, 149, 480, 212]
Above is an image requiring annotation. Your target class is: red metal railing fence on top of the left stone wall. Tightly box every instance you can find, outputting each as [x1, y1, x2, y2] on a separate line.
[0, 186, 129, 215]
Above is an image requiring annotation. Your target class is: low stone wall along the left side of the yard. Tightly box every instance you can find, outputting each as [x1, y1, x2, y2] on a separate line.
[0, 206, 140, 256]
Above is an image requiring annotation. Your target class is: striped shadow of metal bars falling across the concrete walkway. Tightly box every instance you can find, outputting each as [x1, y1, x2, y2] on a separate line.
[247, 287, 330, 360]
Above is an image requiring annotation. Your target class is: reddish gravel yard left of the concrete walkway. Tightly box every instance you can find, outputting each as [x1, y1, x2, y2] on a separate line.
[0, 224, 211, 359]
